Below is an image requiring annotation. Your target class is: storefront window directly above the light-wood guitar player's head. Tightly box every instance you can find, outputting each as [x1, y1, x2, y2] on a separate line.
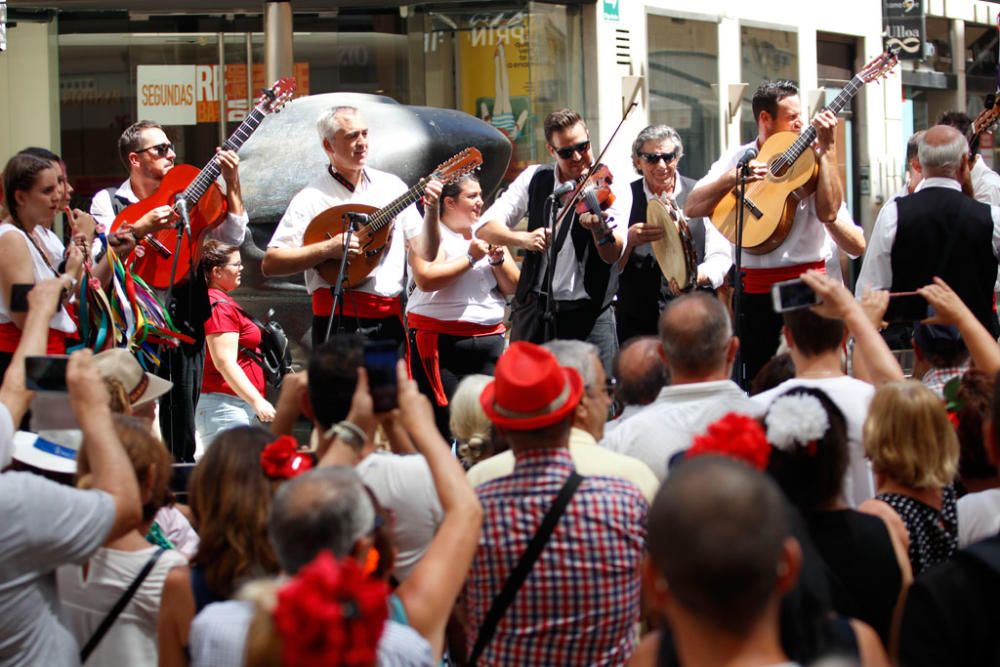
[740, 26, 799, 143]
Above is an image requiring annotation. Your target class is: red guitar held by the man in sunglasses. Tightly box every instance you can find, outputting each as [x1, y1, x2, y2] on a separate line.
[111, 77, 295, 289]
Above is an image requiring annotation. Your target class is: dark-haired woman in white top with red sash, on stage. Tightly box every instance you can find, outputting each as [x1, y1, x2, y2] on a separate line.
[406, 174, 520, 438]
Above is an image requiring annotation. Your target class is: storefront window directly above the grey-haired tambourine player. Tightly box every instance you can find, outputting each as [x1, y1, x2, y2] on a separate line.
[647, 15, 720, 178]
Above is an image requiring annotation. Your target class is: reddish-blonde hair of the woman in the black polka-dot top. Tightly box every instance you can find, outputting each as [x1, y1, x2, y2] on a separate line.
[863, 380, 959, 489]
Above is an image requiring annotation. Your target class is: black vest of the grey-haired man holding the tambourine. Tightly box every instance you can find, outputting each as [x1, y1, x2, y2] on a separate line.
[615, 174, 705, 341]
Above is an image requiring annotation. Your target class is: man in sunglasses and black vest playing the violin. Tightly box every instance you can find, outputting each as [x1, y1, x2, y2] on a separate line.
[477, 109, 629, 372]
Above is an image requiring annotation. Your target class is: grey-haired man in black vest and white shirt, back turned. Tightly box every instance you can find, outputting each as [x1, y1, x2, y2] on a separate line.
[857, 125, 1000, 348]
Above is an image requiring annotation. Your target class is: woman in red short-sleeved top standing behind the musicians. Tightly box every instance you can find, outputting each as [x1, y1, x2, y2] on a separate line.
[195, 239, 274, 447]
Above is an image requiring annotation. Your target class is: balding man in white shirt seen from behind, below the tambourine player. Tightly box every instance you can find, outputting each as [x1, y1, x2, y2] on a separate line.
[602, 292, 762, 480]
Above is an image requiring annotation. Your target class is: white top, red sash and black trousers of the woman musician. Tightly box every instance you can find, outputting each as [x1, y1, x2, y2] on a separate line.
[406, 224, 507, 407]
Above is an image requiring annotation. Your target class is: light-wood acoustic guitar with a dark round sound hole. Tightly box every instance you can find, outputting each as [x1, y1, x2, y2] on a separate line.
[712, 47, 899, 255]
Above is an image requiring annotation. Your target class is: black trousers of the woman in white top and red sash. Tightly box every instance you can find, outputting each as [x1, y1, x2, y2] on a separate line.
[409, 329, 504, 440]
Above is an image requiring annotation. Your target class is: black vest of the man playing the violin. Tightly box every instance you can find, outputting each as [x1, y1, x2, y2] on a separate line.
[514, 165, 618, 318]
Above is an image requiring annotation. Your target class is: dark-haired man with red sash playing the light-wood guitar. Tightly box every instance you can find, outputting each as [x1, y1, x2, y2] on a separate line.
[684, 80, 865, 381]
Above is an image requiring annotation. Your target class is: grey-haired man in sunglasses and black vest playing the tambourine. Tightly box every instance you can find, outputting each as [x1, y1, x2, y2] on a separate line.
[615, 125, 732, 343]
